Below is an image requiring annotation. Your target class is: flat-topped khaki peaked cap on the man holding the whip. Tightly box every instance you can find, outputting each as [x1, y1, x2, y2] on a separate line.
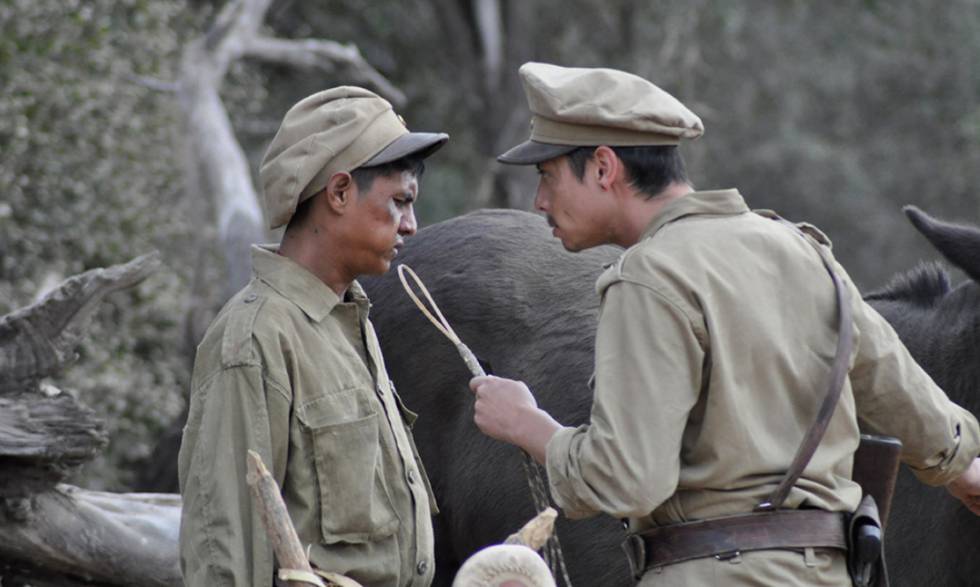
[497, 63, 704, 165]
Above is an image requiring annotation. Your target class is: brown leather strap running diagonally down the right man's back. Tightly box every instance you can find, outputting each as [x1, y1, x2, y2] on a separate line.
[756, 217, 854, 511]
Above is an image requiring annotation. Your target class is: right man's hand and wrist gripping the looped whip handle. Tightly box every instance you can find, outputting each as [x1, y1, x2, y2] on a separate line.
[470, 376, 561, 463]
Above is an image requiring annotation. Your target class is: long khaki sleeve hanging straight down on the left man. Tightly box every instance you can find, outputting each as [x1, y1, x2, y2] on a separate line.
[179, 365, 288, 587]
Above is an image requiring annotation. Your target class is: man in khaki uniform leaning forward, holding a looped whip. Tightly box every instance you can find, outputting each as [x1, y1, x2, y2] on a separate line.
[471, 63, 980, 586]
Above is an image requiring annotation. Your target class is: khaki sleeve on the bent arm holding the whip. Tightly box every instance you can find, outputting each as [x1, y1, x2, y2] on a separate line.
[547, 281, 704, 517]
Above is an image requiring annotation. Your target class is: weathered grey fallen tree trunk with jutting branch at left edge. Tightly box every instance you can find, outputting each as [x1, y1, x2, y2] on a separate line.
[0, 254, 182, 587]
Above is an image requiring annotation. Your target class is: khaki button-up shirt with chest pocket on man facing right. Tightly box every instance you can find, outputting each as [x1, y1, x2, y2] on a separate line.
[179, 247, 435, 587]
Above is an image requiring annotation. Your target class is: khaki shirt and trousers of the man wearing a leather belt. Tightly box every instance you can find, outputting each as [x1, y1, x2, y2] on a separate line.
[547, 190, 980, 585]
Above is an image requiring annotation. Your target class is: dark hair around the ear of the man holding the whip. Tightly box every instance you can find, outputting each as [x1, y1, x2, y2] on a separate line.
[568, 145, 690, 200]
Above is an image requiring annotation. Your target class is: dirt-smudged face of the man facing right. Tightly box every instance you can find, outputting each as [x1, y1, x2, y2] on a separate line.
[344, 171, 419, 276]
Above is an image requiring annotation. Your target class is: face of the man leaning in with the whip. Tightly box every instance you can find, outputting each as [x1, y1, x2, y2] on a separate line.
[534, 157, 611, 252]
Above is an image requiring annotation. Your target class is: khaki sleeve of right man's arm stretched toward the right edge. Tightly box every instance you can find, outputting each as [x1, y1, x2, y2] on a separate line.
[851, 288, 980, 485]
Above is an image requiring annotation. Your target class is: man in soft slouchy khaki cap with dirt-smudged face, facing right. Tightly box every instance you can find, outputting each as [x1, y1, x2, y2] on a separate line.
[179, 87, 448, 587]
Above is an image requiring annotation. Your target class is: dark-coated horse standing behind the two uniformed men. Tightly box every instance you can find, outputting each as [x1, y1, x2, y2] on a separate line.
[365, 209, 980, 586]
